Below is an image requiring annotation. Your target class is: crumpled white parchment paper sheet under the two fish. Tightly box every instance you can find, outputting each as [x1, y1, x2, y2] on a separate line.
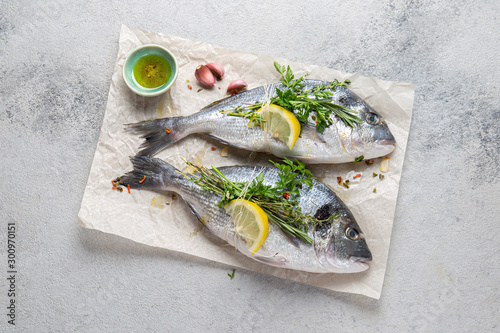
[78, 26, 415, 299]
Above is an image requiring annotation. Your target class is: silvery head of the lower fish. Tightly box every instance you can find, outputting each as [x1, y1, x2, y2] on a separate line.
[314, 205, 372, 273]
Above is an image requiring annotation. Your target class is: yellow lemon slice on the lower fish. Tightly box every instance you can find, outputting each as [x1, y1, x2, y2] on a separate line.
[224, 199, 269, 254]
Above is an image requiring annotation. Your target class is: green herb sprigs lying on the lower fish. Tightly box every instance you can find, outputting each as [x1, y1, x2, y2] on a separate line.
[178, 158, 335, 243]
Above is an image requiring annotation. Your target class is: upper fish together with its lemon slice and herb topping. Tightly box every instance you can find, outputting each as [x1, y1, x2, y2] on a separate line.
[127, 74, 396, 164]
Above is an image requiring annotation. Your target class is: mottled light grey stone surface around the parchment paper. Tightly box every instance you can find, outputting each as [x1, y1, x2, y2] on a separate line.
[0, 0, 500, 332]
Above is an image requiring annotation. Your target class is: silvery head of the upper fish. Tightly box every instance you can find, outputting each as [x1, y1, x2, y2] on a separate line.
[337, 104, 396, 159]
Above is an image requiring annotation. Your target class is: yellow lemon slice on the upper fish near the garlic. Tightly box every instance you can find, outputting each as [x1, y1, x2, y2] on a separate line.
[248, 104, 300, 149]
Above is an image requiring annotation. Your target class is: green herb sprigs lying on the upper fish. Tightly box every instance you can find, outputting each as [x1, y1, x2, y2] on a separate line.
[222, 62, 361, 133]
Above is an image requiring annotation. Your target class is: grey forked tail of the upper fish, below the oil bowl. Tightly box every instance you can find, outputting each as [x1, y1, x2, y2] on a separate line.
[126, 117, 188, 156]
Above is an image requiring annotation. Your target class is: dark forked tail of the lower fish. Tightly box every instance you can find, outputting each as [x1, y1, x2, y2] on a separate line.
[116, 156, 178, 189]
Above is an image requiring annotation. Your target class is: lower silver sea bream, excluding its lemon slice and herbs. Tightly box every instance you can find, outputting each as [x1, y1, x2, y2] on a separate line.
[120, 156, 372, 273]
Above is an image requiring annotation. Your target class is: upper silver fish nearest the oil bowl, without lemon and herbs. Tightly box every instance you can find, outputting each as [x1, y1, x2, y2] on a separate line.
[129, 80, 396, 164]
